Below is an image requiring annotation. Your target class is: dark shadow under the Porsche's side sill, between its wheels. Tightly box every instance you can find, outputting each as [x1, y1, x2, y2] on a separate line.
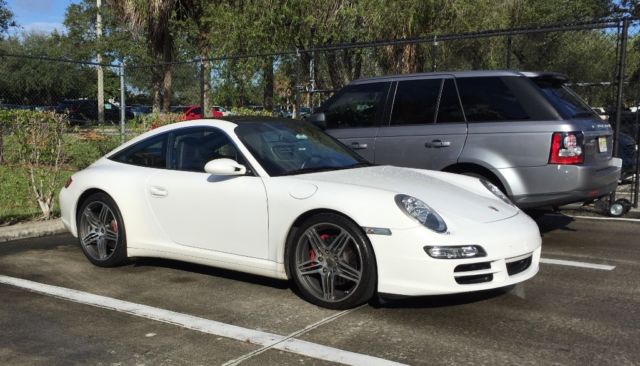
[132, 258, 290, 290]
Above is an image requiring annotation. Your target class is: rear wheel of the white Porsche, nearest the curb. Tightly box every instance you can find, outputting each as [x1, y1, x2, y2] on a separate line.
[76, 193, 127, 267]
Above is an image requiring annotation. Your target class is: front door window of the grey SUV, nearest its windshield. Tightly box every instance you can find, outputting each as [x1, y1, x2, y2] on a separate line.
[324, 83, 389, 128]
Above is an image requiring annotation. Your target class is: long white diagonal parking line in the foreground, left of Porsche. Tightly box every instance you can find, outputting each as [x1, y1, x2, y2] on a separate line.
[0, 275, 402, 366]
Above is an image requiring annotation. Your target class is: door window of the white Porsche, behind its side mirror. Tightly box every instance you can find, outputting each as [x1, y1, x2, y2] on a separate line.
[171, 128, 245, 172]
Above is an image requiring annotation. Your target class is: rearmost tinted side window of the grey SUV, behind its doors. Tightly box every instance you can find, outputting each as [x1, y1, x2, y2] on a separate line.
[457, 77, 530, 122]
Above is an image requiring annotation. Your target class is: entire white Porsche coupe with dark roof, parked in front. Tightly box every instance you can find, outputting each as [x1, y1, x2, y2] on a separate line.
[60, 117, 541, 309]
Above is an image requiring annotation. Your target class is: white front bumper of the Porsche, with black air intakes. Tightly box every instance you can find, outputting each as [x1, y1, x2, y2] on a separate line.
[369, 213, 541, 296]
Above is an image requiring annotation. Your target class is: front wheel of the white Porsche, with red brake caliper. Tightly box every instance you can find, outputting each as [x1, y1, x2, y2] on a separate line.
[289, 213, 377, 309]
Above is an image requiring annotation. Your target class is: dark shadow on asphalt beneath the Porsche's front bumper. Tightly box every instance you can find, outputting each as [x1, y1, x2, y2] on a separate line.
[369, 285, 515, 309]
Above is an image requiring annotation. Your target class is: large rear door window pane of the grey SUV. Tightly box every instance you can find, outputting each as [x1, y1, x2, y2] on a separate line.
[391, 79, 442, 125]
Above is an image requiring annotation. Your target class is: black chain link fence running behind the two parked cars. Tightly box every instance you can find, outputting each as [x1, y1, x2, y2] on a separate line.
[0, 19, 640, 207]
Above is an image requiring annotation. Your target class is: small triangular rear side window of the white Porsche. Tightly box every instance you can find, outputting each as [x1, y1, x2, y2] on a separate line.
[111, 133, 167, 168]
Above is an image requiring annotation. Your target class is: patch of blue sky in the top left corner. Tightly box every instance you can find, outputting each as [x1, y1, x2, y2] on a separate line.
[7, 0, 79, 33]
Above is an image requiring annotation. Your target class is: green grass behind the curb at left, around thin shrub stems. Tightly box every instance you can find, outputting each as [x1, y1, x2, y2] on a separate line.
[0, 165, 73, 225]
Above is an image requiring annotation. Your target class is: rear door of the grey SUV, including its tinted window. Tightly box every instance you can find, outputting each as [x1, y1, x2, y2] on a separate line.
[374, 75, 467, 170]
